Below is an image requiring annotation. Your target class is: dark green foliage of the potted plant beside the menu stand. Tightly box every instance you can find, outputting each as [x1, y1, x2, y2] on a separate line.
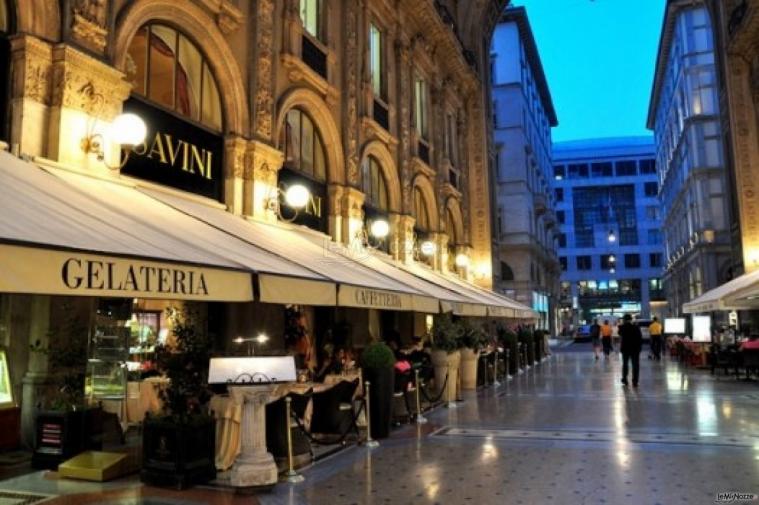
[155, 305, 211, 419]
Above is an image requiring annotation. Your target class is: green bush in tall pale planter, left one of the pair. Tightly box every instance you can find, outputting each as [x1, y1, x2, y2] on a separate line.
[430, 314, 461, 403]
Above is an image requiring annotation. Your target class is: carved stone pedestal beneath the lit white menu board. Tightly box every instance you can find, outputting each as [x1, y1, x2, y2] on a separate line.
[229, 384, 277, 487]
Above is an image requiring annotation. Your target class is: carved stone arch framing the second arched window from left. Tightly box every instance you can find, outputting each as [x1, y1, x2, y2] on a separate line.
[274, 88, 345, 184]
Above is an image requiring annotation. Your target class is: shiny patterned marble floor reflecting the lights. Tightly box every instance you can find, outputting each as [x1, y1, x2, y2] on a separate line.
[0, 345, 759, 505]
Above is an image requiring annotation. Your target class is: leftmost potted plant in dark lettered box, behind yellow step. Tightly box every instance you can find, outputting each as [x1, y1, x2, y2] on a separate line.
[30, 302, 102, 469]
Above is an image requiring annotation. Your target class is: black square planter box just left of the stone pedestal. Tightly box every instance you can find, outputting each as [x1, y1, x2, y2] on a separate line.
[140, 416, 216, 489]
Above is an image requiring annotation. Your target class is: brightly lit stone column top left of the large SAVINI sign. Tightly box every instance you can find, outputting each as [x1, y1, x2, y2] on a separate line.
[43, 44, 130, 173]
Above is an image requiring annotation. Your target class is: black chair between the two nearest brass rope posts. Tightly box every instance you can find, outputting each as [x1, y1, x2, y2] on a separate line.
[311, 379, 359, 441]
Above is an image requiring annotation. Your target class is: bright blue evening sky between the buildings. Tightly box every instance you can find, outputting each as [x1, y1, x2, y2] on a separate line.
[512, 0, 665, 142]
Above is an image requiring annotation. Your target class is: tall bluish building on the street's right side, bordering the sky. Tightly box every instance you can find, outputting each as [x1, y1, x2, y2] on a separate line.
[647, 0, 736, 314]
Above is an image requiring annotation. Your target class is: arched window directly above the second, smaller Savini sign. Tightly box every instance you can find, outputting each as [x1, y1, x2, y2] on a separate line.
[279, 109, 327, 181]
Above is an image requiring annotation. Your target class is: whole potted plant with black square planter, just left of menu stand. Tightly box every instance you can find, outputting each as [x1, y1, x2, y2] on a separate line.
[140, 306, 216, 489]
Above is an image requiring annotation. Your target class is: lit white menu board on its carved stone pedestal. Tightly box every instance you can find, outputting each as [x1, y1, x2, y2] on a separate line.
[208, 356, 296, 488]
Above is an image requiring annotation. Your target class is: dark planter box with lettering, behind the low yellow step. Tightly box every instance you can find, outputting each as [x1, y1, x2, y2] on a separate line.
[32, 407, 103, 470]
